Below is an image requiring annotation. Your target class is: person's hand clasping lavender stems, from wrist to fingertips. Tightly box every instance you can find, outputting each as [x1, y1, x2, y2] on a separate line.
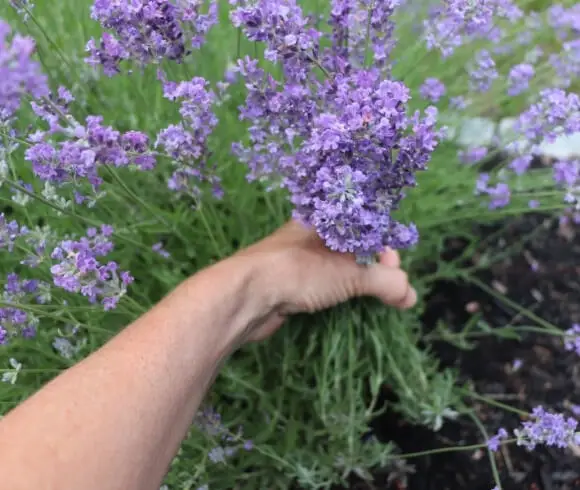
[234, 221, 417, 340]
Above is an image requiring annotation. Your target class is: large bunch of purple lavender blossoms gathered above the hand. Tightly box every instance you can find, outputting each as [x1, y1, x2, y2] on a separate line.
[232, 0, 441, 261]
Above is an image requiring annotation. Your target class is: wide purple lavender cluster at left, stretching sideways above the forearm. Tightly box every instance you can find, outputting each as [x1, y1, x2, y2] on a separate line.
[25, 87, 156, 204]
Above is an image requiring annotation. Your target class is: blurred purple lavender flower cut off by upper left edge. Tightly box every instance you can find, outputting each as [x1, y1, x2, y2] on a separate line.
[0, 20, 48, 122]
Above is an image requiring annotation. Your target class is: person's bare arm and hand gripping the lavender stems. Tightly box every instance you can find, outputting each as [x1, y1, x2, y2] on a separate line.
[0, 222, 416, 490]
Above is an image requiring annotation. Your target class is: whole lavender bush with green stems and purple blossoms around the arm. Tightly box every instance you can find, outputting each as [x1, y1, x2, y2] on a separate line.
[0, 0, 580, 490]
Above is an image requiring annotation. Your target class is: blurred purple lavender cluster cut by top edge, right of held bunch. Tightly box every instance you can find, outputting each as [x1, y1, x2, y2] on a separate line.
[424, 0, 523, 57]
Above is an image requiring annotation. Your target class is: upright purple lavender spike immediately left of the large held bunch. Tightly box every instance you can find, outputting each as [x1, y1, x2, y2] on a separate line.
[155, 77, 222, 197]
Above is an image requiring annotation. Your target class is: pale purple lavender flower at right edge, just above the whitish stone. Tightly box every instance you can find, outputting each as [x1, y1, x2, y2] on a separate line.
[514, 88, 580, 144]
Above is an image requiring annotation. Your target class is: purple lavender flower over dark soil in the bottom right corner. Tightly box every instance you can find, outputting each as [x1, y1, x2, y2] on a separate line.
[514, 406, 579, 451]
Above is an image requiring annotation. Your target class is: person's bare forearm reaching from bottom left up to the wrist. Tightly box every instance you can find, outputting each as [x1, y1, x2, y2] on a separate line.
[0, 261, 260, 490]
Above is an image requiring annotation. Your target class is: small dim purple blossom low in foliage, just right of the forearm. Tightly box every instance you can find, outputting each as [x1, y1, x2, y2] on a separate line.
[193, 407, 254, 464]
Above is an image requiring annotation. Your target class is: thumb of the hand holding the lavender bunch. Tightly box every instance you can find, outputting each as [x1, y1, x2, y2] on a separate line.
[361, 263, 417, 309]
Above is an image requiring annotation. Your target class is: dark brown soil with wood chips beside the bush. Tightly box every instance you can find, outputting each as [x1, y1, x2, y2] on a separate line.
[350, 215, 580, 490]
